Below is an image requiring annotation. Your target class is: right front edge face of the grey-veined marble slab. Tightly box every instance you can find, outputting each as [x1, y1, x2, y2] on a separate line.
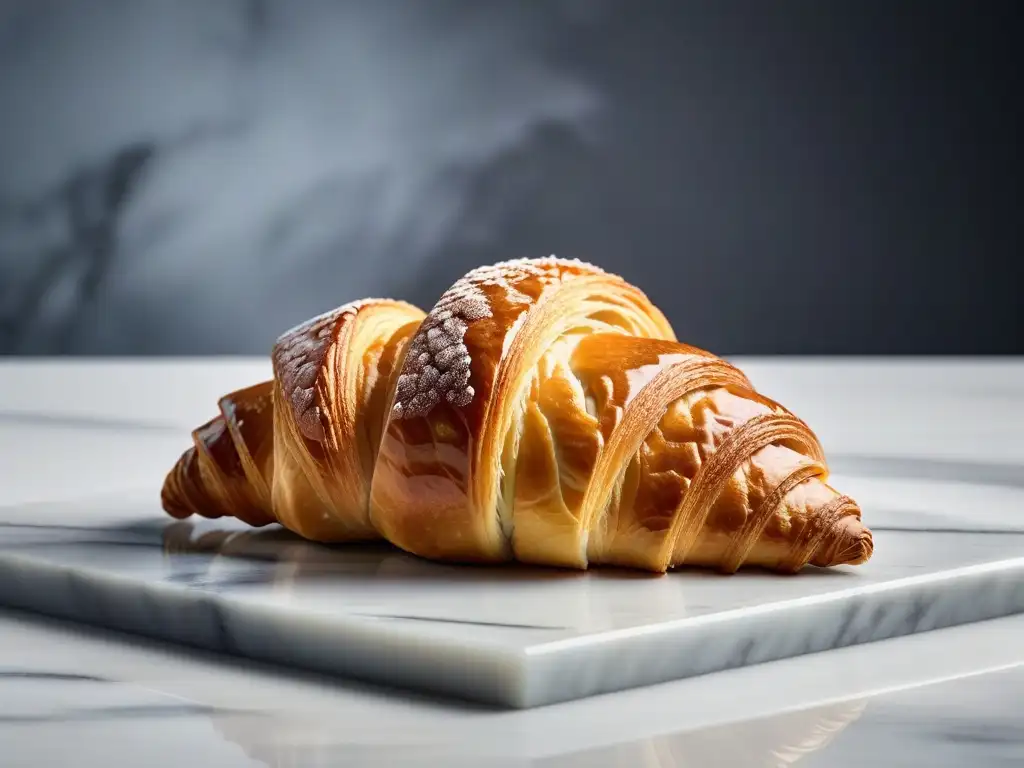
[523, 557, 1024, 706]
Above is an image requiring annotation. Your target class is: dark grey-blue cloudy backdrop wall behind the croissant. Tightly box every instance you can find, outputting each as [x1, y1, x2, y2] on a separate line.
[0, 0, 1024, 354]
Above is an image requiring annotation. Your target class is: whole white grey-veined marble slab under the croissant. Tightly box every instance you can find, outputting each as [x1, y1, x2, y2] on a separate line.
[0, 478, 1024, 708]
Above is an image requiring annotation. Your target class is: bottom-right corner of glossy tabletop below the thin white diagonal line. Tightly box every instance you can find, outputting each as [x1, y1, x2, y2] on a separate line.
[548, 666, 1024, 768]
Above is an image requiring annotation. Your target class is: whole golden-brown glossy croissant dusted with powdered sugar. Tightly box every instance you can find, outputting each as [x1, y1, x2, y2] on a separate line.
[162, 257, 873, 573]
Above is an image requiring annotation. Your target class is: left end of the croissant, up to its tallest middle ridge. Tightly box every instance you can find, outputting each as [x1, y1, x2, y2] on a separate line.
[162, 299, 424, 542]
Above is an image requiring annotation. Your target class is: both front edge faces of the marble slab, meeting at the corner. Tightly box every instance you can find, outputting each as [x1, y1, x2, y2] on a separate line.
[0, 553, 1024, 709]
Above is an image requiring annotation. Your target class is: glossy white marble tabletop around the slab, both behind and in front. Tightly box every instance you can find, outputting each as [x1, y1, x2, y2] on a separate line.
[0, 360, 1024, 768]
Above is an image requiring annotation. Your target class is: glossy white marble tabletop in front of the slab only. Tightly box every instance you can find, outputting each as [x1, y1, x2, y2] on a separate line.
[0, 613, 1024, 768]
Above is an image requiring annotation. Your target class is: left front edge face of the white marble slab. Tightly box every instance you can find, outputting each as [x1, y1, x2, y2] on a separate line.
[0, 553, 525, 706]
